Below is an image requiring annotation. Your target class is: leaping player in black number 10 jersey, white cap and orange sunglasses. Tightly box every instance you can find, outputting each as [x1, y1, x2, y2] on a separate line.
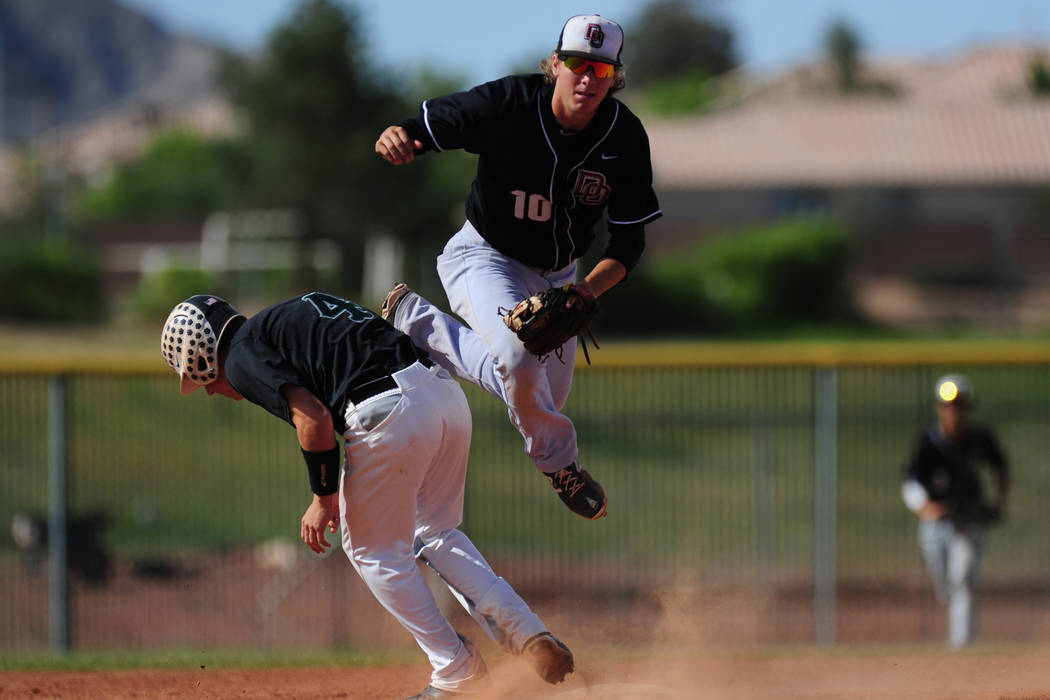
[376, 15, 660, 518]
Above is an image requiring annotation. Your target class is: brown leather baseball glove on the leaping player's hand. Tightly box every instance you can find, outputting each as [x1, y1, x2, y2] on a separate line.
[500, 284, 600, 364]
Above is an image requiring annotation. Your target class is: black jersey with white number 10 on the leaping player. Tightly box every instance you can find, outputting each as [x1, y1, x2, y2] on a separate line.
[400, 73, 662, 271]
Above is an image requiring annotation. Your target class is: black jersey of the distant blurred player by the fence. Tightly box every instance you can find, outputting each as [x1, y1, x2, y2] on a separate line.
[904, 425, 1009, 523]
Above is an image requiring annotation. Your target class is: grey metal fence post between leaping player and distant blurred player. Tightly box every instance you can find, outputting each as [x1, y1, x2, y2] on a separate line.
[814, 367, 838, 644]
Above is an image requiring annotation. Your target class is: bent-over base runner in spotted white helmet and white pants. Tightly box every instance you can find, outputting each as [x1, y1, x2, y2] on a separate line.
[161, 292, 573, 698]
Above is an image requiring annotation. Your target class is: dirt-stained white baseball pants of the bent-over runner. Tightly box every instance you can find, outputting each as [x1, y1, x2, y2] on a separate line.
[339, 362, 546, 691]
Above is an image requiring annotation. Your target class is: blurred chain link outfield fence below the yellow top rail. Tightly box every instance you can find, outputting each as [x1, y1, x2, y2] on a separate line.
[0, 353, 1050, 654]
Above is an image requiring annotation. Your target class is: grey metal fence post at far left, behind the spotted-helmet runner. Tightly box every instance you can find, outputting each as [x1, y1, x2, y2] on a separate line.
[47, 375, 69, 654]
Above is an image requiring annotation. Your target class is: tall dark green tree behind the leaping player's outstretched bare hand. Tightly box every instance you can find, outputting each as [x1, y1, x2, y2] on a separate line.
[222, 0, 464, 291]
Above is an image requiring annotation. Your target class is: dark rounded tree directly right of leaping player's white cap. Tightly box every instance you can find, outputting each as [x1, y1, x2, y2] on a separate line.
[624, 0, 737, 88]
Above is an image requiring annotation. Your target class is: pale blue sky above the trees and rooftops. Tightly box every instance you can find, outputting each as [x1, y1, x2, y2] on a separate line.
[120, 0, 1050, 83]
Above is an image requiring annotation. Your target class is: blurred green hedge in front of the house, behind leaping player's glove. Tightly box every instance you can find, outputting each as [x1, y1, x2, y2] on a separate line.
[600, 215, 859, 337]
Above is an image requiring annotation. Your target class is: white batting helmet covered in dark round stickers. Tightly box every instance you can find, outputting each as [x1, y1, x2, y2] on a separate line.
[161, 294, 245, 394]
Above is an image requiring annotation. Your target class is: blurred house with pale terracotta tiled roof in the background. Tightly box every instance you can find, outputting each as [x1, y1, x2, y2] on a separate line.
[646, 46, 1050, 327]
